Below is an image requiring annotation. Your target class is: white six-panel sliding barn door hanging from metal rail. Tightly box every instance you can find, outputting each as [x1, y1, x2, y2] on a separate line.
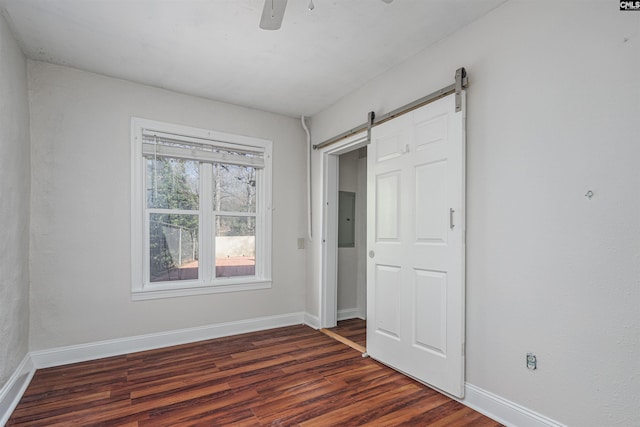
[367, 92, 465, 397]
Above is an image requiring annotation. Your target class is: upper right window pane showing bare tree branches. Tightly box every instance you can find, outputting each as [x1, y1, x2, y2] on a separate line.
[213, 163, 256, 212]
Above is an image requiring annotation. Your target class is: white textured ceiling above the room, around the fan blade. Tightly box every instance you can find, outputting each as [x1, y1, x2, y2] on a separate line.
[0, 0, 505, 116]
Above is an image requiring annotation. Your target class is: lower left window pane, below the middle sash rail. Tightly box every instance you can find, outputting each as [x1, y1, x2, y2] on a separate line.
[149, 214, 198, 282]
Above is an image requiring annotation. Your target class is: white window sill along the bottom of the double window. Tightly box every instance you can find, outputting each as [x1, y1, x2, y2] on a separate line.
[131, 280, 271, 301]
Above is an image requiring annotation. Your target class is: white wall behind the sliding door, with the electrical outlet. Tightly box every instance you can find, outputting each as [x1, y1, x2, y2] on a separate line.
[307, 0, 640, 426]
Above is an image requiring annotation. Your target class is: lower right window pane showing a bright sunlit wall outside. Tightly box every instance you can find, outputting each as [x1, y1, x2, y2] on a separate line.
[216, 216, 256, 277]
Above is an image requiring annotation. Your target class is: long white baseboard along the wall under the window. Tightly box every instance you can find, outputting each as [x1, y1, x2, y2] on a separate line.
[31, 312, 306, 369]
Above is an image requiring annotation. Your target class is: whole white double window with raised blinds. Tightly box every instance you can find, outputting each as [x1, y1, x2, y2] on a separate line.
[131, 118, 271, 300]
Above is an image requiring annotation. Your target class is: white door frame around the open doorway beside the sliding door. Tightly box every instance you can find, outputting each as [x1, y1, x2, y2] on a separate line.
[319, 131, 369, 328]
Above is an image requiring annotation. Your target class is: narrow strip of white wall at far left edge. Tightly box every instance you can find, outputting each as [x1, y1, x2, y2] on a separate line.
[0, 15, 30, 389]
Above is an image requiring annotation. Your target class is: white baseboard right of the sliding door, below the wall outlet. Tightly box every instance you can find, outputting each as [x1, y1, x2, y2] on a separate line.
[458, 383, 566, 427]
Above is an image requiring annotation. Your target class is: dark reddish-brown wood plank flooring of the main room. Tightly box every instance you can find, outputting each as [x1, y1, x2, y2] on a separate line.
[7, 326, 500, 427]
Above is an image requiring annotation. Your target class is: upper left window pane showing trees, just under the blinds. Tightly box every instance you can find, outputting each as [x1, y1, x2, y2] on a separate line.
[146, 156, 200, 210]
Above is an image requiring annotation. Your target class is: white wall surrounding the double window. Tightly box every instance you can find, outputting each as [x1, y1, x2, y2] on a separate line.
[28, 61, 306, 350]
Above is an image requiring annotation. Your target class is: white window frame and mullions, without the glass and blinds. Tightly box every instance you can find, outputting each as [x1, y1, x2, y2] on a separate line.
[131, 117, 272, 301]
